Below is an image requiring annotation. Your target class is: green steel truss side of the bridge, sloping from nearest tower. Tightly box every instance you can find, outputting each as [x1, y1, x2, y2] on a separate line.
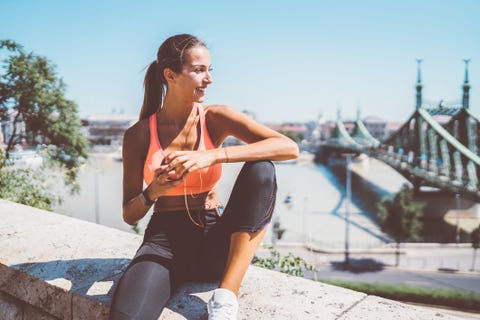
[376, 109, 480, 194]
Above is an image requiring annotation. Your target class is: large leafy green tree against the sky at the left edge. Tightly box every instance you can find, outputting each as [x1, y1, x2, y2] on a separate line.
[0, 40, 87, 190]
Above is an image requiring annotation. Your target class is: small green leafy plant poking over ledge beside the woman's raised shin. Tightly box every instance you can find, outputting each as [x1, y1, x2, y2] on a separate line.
[252, 248, 315, 277]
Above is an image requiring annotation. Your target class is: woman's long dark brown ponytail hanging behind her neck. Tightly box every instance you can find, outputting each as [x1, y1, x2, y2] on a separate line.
[140, 60, 164, 120]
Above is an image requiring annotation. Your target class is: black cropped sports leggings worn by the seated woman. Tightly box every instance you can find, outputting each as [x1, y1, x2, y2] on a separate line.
[110, 161, 277, 320]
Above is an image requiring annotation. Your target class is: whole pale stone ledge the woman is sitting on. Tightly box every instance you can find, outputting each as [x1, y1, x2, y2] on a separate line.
[0, 200, 462, 320]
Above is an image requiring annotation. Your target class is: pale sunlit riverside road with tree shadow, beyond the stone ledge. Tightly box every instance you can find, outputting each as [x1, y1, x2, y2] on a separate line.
[256, 244, 480, 294]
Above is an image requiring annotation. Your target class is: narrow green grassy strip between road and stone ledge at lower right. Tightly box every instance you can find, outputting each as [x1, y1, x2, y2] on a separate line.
[321, 280, 480, 311]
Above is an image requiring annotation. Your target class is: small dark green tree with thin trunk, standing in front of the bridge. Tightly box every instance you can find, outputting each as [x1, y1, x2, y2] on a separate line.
[377, 184, 425, 266]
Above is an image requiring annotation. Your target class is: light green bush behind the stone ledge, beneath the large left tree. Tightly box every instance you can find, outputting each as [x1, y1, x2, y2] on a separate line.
[0, 149, 60, 210]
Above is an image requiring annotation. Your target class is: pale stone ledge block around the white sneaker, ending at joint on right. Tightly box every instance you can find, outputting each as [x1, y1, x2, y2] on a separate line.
[160, 266, 366, 320]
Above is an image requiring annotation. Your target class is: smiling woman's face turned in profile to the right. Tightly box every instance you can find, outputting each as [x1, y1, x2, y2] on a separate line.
[175, 46, 212, 102]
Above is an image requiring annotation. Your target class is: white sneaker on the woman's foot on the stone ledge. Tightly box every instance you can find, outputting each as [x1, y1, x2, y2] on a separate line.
[207, 288, 238, 320]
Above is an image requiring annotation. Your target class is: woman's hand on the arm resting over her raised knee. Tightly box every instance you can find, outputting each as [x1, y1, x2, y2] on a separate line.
[164, 149, 221, 179]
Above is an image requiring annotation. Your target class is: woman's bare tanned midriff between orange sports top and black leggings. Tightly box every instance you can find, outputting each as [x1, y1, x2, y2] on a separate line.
[153, 189, 221, 212]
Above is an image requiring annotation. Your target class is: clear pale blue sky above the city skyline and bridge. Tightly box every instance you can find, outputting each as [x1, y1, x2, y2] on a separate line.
[0, 0, 480, 122]
